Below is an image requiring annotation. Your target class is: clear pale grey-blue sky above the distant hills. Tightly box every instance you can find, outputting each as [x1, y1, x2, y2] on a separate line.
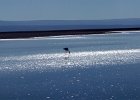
[0, 0, 140, 21]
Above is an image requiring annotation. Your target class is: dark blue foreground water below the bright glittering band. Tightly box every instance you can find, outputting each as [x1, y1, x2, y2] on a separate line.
[0, 64, 140, 100]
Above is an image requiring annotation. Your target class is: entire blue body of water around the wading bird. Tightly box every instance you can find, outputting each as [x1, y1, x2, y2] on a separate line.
[0, 32, 140, 100]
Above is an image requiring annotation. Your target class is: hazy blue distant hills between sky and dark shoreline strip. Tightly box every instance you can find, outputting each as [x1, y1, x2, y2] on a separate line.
[0, 18, 140, 32]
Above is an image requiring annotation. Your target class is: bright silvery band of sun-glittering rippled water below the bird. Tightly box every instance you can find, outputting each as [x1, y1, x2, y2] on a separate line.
[0, 49, 140, 71]
